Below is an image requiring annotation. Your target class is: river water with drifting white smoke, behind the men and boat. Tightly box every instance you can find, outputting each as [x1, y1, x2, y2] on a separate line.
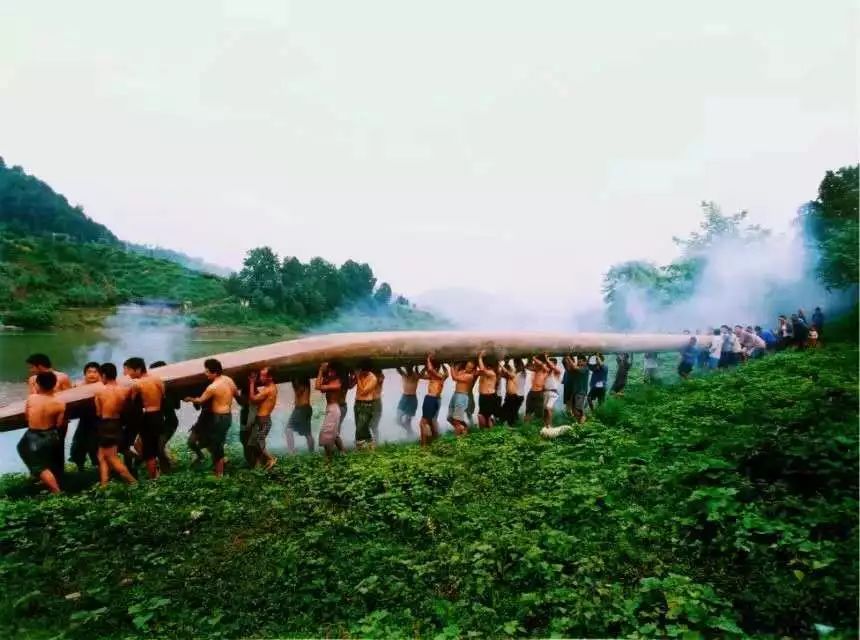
[0, 305, 440, 473]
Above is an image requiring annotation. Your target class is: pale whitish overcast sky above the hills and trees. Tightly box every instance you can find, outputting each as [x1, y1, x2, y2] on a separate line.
[0, 0, 858, 305]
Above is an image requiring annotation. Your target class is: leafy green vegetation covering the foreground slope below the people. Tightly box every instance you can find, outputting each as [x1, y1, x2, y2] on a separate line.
[0, 342, 858, 638]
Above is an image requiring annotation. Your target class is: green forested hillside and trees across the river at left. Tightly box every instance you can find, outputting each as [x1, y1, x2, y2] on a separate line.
[0, 159, 438, 333]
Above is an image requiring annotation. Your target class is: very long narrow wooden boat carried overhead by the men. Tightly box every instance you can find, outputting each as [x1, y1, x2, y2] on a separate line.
[0, 331, 710, 431]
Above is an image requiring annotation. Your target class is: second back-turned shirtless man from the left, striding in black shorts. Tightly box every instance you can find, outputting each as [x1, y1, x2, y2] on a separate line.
[95, 362, 137, 487]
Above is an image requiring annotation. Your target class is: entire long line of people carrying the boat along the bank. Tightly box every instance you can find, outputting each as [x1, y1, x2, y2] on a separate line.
[13, 307, 824, 493]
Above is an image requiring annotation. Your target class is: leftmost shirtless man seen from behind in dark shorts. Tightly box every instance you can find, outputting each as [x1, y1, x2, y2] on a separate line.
[18, 371, 66, 493]
